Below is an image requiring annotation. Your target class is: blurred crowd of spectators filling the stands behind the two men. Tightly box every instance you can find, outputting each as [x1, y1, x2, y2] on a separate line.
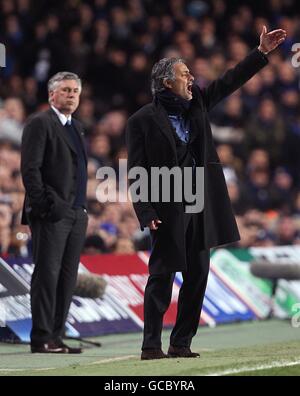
[0, 0, 300, 256]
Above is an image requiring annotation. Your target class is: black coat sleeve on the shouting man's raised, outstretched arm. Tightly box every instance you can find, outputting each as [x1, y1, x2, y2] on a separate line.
[201, 48, 268, 111]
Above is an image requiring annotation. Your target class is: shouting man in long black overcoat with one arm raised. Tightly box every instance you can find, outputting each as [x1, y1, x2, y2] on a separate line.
[126, 27, 286, 359]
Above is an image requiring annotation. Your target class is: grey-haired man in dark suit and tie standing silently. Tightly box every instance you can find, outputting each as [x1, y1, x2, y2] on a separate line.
[21, 72, 88, 353]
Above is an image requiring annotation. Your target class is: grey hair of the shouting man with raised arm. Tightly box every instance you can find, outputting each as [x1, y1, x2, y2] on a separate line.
[151, 57, 185, 95]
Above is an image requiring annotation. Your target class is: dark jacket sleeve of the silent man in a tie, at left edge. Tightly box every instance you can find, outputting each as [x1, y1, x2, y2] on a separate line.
[21, 117, 49, 214]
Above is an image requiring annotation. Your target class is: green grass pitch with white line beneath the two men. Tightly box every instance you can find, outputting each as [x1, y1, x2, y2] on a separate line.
[0, 320, 300, 376]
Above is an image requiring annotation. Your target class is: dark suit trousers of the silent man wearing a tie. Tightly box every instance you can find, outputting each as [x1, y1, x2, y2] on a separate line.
[29, 208, 88, 345]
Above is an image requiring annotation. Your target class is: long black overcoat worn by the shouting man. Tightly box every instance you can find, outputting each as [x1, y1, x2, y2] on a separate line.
[126, 49, 268, 273]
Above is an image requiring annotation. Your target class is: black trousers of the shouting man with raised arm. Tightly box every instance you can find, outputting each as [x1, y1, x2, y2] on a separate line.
[142, 214, 209, 349]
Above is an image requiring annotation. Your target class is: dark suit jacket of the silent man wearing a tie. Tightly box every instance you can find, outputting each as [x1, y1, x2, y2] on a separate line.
[21, 109, 87, 224]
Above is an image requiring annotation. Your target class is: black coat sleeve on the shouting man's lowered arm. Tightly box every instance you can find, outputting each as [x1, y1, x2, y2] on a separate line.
[126, 119, 159, 231]
